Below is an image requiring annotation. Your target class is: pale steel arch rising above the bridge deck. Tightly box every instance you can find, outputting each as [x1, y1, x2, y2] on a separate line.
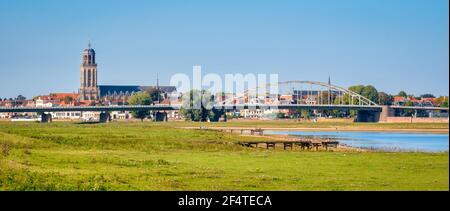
[225, 81, 379, 107]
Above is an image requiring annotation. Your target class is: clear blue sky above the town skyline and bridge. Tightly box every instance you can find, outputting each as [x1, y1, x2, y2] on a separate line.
[0, 0, 449, 98]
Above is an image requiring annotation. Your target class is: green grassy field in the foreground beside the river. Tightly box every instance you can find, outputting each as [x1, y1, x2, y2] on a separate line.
[0, 122, 449, 191]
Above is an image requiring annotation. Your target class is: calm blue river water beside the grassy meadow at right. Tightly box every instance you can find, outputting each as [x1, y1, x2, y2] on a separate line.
[264, 131, 449, 152]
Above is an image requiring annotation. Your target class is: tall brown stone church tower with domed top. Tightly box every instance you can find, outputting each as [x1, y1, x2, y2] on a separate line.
[79, 42, 99, 100]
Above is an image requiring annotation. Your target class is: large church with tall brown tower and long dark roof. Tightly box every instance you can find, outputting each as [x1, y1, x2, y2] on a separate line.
[79, 43, 176, 101]
